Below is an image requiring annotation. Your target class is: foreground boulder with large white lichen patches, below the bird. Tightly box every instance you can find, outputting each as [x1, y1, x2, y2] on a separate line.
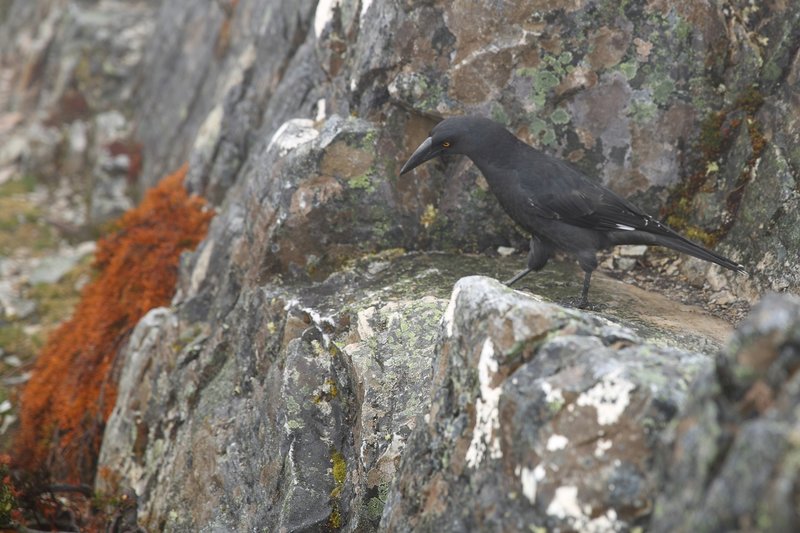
[382, 277, 710, 532]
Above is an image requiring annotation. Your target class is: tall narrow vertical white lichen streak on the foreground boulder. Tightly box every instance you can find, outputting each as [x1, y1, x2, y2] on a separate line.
[466, 338, 503, 468]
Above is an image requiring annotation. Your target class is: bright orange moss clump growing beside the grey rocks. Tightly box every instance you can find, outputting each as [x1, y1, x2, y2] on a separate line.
[15, 165, 213, 483]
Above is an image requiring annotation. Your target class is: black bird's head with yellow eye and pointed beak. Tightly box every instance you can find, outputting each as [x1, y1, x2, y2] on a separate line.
[400, 117, 510, 174]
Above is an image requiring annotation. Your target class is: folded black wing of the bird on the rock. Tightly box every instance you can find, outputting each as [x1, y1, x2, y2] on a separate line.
[519, 157, 674, 235]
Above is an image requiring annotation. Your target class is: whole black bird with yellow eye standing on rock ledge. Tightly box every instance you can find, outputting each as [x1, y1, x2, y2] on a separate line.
[400, 117, 747, 307]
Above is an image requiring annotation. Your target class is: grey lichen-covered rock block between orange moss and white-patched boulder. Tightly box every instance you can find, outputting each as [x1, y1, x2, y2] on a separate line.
[98, 252, 446, 531]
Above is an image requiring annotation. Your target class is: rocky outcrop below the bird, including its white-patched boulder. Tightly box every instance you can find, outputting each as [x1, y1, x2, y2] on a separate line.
[99, 255, 716, 531]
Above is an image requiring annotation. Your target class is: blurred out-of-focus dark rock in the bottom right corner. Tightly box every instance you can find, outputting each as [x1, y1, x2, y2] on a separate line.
[650, 295, 800, 532]
